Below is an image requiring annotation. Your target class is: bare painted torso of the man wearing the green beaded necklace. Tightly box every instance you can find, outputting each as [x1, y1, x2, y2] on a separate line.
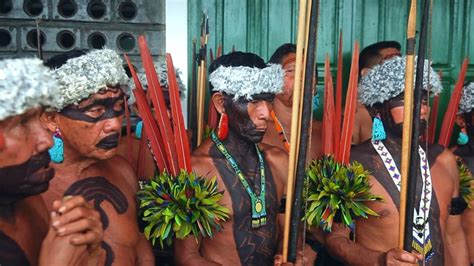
[175, 140, 288, 265]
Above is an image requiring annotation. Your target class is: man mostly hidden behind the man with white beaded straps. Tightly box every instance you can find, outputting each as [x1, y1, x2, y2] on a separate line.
[352, 41, 401, 144]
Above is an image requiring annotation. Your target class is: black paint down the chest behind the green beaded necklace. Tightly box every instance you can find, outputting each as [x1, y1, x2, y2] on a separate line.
[209, 146, 279, 266]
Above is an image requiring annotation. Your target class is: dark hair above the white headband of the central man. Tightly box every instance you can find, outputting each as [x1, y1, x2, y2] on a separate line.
[209, 52, 267, 95]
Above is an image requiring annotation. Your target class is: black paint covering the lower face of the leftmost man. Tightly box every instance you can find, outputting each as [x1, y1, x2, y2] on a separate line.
[0, 151, 54, 205]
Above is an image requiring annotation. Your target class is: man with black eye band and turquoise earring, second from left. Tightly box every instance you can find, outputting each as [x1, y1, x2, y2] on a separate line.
[43, 49, 154, 265]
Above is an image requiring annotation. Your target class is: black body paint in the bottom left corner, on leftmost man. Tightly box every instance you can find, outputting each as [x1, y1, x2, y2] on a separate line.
[0, 231, 30, 266]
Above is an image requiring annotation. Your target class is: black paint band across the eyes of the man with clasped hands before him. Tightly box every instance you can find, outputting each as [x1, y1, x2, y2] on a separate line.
[60, 95, 125, 123]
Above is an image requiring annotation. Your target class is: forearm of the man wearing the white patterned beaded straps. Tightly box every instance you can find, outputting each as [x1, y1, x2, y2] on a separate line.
[326, 236, 385, 265]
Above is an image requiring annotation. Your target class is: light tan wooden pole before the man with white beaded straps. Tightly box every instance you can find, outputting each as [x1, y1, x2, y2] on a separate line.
[398, 0, 416, 249]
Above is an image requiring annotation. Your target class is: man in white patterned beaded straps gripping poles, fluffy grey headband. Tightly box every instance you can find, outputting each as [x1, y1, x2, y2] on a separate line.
[326, 57, 468, 265]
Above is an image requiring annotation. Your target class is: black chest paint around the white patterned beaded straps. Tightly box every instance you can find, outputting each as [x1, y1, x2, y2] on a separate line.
[351, 138, 444, 266]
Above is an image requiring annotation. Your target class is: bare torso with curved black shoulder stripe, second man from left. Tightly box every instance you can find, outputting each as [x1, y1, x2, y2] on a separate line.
[43, 156, 149, 265]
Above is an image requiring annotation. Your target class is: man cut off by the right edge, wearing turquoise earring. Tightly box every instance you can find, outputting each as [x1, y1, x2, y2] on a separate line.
[454, 82, 474, 265]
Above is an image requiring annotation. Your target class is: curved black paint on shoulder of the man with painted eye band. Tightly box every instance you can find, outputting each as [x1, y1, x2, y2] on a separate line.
[64, 176, 128, 266]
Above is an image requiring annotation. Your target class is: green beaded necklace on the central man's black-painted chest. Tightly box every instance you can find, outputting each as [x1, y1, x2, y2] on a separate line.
[211, 132, 267, 228]
